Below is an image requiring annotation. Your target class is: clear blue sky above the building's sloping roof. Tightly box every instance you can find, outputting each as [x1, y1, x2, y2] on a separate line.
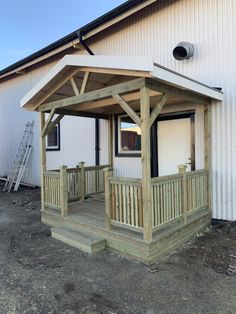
[0, 0, 125, 69]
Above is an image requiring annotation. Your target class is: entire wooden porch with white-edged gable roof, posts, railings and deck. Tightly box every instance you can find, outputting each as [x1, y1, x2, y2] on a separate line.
[20, 56, 222, 263]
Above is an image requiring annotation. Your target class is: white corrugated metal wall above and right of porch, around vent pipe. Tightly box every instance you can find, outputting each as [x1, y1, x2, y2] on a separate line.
[90, 0, 236, 220]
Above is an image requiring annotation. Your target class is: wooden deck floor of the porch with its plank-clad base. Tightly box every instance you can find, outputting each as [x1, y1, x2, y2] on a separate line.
[41, 198, 211, 264]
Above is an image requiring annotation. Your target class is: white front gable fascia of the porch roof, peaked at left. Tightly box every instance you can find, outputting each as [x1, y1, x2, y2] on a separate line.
[20, 55, 154, 107]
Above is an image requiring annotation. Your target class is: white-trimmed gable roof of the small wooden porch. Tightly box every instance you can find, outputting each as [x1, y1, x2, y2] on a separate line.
[21, 55, 224, 110]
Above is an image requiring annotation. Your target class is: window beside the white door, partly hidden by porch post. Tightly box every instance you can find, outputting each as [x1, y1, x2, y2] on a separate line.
[116, 115, 141, 156]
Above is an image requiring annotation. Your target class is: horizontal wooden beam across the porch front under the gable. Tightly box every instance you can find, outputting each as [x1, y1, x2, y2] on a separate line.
[38, 78, 145, 111]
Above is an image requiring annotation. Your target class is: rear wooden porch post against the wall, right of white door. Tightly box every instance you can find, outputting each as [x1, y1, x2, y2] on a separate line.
[204, 105, 212, 211]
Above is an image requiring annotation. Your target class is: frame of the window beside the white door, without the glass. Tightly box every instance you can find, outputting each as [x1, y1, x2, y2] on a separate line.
[115, 114, 141, 157]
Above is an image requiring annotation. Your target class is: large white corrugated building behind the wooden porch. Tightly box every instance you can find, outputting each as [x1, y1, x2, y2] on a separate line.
[0, 0, 236, 220]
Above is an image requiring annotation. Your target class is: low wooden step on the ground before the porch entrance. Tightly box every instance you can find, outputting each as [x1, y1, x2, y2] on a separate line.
[51, 226, 106, 254]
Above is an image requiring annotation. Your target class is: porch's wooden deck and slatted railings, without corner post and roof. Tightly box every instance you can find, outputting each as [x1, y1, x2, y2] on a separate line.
[42, 163, 211, 264]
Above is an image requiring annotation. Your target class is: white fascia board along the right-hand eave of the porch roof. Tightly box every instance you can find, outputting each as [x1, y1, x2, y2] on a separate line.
[151, 65, 224, 101]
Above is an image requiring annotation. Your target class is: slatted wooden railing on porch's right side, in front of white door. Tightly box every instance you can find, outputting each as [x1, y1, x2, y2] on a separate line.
[151, 166, 209, 229]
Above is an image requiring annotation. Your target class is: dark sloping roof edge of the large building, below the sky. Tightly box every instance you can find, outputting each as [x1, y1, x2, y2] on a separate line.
[0, 0, 157, 78]
